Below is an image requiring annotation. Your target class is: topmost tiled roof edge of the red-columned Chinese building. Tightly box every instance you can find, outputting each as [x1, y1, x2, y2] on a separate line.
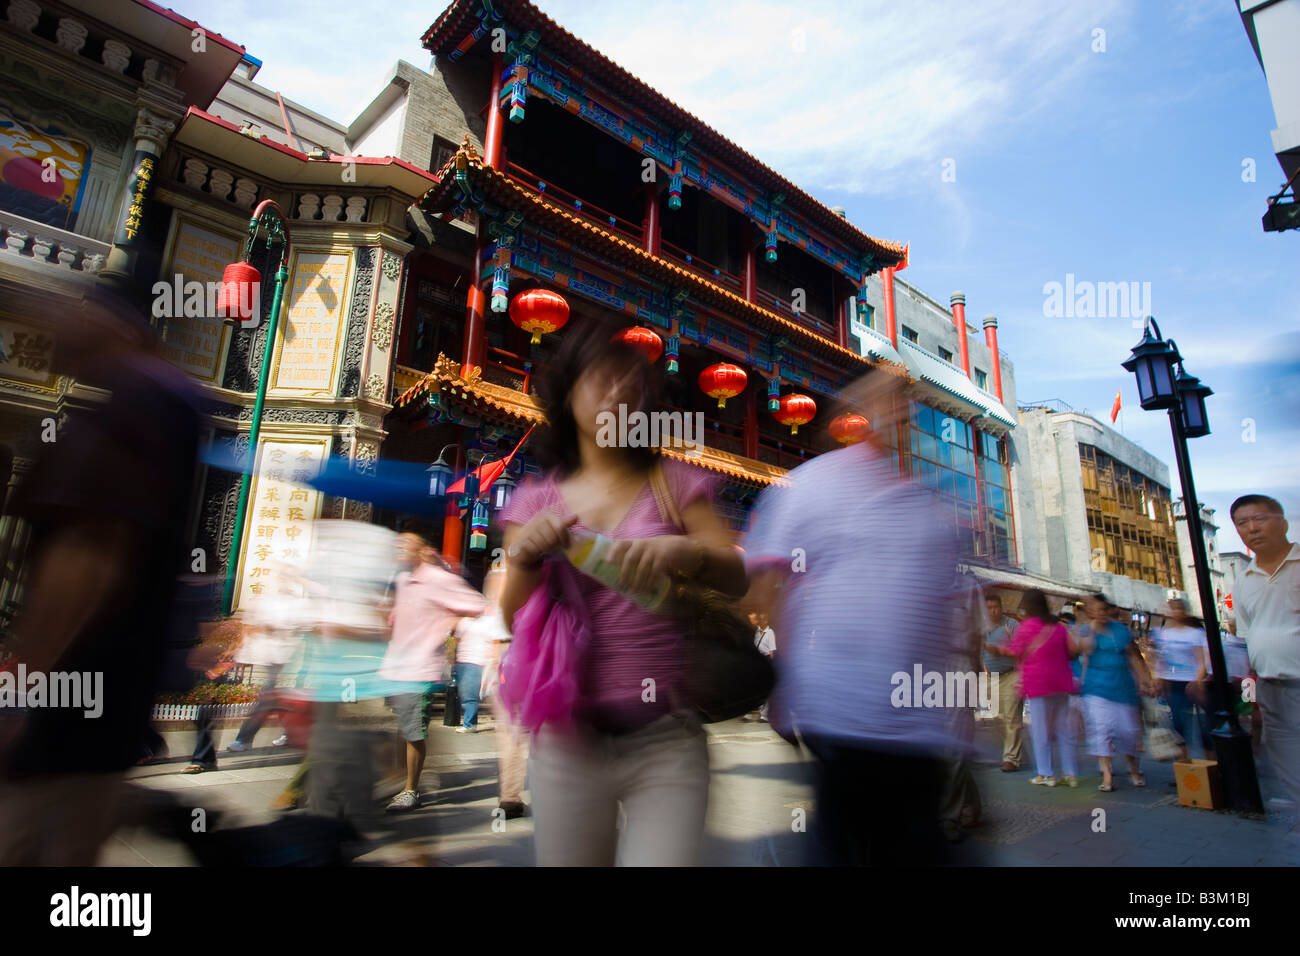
[423, 0, 904, 261]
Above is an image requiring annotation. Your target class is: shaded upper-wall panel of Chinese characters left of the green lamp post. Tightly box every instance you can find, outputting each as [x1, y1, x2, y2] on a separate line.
[163, 220, 241, 382]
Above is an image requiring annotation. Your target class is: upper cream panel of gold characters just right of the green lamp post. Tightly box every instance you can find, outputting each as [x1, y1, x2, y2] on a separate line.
[272, 252, 351, 395]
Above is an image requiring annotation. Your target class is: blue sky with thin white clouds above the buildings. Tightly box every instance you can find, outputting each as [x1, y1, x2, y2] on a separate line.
[176, 0, 1300, 550]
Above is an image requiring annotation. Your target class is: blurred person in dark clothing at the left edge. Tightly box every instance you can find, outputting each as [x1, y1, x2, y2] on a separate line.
[0, 282, 200, 866]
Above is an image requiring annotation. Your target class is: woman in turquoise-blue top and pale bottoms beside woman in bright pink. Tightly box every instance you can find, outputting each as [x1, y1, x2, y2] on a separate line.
[1079, 594, 1152, 793]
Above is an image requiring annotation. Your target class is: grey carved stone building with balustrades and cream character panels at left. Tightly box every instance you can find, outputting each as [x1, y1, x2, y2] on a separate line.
[0, 0, 434, 607]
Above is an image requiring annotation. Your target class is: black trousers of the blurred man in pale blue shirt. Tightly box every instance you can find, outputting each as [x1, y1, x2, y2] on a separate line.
[805, 737, 948, 866]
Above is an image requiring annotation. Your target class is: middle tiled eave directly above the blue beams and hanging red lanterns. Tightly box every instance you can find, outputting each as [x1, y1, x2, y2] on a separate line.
[420, 142, 906, 375]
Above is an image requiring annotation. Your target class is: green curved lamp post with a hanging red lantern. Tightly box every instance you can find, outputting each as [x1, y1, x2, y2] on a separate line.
[217, 199, 289, 614]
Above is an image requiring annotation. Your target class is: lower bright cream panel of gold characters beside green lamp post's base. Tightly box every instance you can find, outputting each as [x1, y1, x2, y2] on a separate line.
[238, 441, 325, 607]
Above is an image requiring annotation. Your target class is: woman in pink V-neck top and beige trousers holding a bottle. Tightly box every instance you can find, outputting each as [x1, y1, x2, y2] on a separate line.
[502, 326, 746, 866]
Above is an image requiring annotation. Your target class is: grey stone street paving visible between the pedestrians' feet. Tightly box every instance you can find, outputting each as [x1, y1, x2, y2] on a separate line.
[103, 721, 1300, 866]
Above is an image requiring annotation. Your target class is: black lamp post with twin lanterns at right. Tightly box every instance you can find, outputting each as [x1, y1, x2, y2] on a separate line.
[1123, 316, 1264, 813]
